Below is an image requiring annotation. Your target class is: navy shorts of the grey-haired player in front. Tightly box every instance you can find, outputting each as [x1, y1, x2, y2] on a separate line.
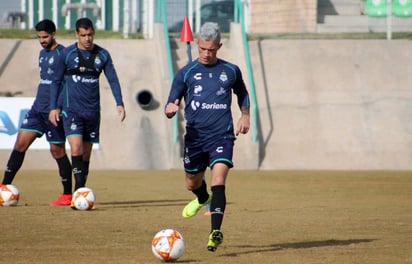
[183, 139, 234, 174]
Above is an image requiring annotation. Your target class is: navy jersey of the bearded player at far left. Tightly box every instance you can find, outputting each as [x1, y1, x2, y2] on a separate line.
[32, 45, 64, 113]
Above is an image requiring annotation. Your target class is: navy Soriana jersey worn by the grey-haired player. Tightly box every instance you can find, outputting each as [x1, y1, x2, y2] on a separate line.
[167, 59, 250, 146]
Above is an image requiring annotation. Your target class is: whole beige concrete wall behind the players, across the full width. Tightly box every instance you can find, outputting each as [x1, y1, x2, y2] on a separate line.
[0, 36, 412, 170]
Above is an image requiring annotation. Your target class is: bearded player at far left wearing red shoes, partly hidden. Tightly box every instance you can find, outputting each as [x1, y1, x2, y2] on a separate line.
[2, 19, 72, 206]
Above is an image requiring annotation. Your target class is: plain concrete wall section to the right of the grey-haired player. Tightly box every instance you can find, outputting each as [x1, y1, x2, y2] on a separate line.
[250, 40, 412, 170]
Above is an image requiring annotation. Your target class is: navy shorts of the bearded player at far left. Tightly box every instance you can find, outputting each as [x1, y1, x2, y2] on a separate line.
[20, 109, 66, 144]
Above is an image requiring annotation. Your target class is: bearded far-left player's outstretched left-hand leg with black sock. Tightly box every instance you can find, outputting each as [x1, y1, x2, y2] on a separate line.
[2, 130, 37, 184]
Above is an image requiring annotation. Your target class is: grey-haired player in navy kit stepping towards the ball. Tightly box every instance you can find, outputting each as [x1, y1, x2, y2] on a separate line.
[165, 22, 250, 251]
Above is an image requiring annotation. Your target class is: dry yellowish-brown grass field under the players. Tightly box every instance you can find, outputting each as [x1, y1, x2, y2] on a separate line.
[0, 170, 412, 264]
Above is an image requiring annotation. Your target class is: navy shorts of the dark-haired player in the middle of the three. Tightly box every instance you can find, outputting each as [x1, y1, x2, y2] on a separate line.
[63, 109, 100, 143]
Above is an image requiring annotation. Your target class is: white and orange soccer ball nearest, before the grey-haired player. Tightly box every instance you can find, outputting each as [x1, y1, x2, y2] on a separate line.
[152, 228, 185, 262]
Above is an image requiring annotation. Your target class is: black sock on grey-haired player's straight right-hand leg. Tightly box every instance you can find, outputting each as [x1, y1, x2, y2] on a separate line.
[210, 185, 226, 230]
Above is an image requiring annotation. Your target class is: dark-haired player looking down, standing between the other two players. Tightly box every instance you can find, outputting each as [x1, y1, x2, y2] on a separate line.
[49, 18, 126, 196]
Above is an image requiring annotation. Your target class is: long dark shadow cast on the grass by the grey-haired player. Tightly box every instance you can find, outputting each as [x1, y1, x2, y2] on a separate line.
[222, 239, 376, 257]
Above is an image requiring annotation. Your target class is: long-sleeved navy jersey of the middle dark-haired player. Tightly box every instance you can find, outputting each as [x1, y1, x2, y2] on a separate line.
[50, 43, 123, 112]
